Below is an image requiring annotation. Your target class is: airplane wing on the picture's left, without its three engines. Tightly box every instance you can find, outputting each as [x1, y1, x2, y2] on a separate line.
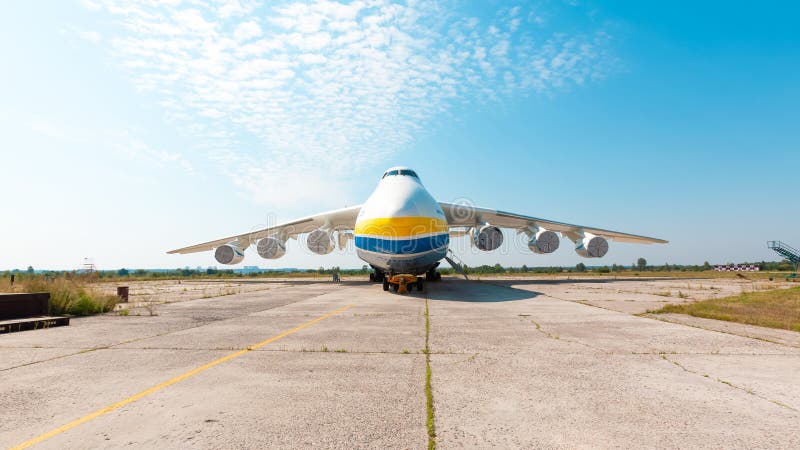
[167, 205, 361, 254]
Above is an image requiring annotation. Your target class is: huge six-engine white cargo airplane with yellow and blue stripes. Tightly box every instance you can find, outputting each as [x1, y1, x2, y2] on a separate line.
[168, 167, 667, 291]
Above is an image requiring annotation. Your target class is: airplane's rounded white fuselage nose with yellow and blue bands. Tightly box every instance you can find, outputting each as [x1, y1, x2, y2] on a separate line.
[355, 171, 450, 275]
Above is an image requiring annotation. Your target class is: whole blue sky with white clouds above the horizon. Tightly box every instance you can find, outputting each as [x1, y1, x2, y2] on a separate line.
[0, 0, 800, 269]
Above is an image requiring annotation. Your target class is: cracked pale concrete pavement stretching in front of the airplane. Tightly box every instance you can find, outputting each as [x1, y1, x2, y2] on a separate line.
[0, 279, 800, 448]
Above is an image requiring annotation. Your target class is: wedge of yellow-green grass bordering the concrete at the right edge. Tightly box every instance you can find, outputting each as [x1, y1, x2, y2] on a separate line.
[650, 287, 800, 331]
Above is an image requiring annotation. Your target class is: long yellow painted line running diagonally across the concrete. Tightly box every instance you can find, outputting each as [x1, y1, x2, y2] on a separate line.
[11, 305, 353, 450]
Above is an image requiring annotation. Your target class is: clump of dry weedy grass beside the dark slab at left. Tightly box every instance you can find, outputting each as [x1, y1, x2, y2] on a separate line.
[4, 277, 119, 316]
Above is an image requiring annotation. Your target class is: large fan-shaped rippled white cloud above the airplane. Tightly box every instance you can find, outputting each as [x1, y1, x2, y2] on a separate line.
[85, 0, 614, 204]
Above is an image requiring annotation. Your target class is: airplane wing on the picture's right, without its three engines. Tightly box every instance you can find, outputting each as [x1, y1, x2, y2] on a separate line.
[439, 202, 668, 244]
